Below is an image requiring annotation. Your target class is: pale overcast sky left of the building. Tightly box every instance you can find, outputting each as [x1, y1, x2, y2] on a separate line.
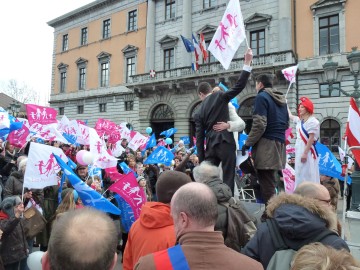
[0, 0, 94, 105]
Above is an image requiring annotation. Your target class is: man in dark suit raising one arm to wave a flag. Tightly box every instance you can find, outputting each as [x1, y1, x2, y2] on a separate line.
[194, 49, 253, 195]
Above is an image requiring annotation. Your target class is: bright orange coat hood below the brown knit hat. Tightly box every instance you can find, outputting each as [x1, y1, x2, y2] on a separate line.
[140, 202, 174, 229]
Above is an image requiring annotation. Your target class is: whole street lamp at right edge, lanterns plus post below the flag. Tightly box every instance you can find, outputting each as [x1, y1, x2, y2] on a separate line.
[323, 47, 360, 211]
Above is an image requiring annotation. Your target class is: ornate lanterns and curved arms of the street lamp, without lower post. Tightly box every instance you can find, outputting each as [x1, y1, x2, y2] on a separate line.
[323, 47, 360, 107]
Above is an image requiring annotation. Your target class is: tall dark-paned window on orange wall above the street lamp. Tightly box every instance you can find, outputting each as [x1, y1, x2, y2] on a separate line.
[319, 15, 340, 55]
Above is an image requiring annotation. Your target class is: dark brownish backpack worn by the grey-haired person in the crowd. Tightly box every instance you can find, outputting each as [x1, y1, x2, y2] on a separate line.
[221, 197, 257, 252]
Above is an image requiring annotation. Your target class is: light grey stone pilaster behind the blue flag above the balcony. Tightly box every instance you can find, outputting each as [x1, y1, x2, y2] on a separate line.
[179, 0, 192, 66]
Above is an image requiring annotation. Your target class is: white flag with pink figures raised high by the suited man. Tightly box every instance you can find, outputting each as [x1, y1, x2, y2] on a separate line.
[208, 0, 246, 69]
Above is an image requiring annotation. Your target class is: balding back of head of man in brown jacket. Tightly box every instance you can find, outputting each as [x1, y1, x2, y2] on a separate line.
[171, 182, 218, 228]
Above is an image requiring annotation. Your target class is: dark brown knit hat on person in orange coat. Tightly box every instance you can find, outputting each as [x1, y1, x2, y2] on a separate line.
[156, 171, 191, 203]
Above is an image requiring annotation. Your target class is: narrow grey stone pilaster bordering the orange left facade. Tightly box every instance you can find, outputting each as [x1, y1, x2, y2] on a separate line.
[145, 0, 155, 70]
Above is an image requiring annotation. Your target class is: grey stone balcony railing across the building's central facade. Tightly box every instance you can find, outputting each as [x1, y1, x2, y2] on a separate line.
[127, 51, 295, 85]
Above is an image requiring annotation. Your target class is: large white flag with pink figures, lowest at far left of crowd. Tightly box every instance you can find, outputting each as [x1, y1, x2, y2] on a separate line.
[24, 142, 68, 189]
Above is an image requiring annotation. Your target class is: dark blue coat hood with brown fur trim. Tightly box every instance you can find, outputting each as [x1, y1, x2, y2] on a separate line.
[266, 193, 337, 239]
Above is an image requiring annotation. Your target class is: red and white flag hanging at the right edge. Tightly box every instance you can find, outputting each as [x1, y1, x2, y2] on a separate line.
[345, 98, 360, 164]
